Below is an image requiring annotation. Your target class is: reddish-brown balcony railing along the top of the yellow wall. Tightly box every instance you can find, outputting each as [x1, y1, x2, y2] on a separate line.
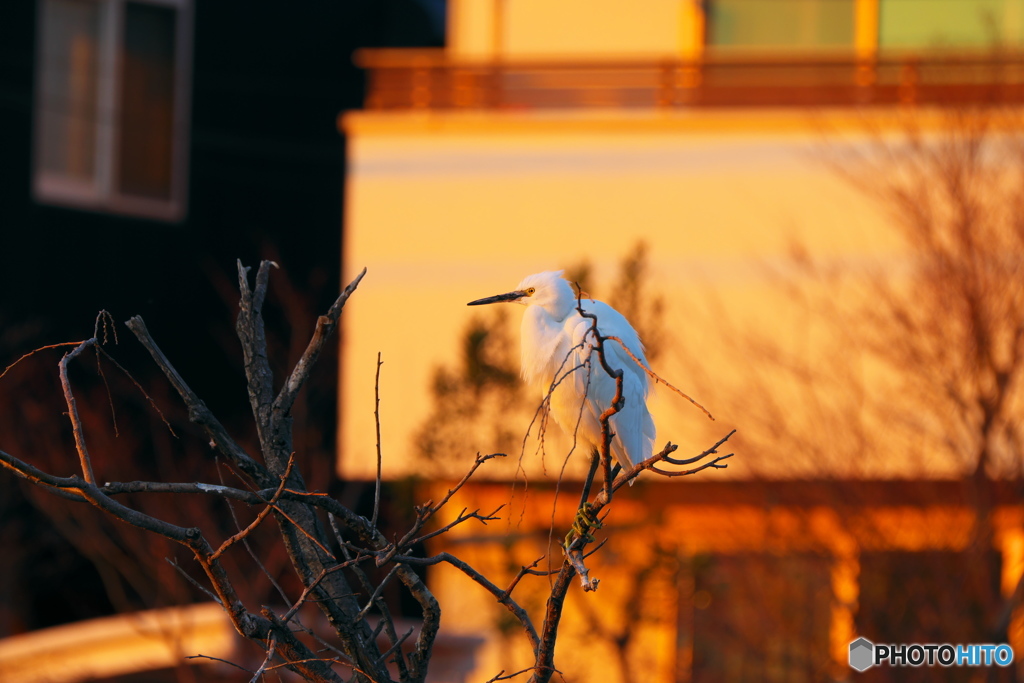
[355, 49, 1024, 111]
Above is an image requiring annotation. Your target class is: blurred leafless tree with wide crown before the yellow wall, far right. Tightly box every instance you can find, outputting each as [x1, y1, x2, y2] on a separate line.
[693, 106, 1024, 680]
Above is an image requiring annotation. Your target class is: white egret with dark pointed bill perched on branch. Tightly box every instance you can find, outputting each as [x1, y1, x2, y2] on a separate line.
[468, 270, 654, 483]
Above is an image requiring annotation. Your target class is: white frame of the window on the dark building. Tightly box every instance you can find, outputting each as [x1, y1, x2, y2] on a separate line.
[32, 0, 193, 222]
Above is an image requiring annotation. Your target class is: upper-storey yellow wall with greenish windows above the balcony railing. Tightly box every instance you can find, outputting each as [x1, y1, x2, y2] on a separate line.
[447, 0, 1024, 60]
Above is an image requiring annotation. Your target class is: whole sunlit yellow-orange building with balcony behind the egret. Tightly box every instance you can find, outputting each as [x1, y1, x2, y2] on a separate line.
[339, 0, 1022, 681]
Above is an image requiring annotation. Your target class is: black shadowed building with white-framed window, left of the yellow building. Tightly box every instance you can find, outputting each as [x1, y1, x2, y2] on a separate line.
[0, 0, 442, 637]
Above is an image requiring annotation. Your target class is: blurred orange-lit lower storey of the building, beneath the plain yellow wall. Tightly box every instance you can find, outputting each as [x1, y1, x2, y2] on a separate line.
[423, 478, 1024, 683]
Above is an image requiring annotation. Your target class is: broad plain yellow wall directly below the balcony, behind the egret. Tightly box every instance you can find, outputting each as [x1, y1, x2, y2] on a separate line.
[340, 111, 901, 478]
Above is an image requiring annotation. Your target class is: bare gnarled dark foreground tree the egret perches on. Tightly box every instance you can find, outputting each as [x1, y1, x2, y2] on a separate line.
[0, 261, 728, 683]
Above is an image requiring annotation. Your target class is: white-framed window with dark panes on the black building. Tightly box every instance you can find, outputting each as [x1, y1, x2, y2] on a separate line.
[33, 0, 191, 220]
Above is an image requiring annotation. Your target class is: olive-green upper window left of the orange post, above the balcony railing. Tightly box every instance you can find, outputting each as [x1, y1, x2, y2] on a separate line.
[707, 0, 854, 52]
